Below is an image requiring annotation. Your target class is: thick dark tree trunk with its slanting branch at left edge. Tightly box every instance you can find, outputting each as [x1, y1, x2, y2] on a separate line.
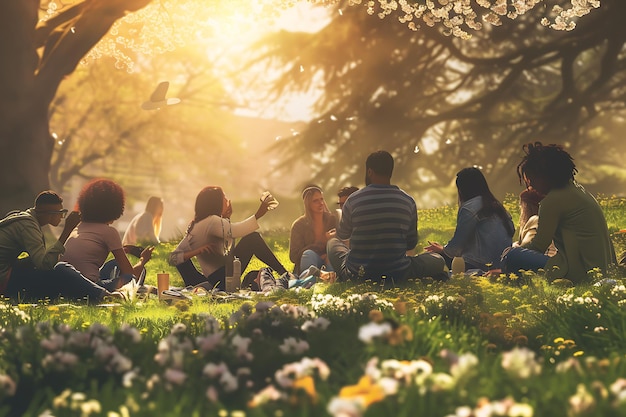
[0, 0, 151, 216]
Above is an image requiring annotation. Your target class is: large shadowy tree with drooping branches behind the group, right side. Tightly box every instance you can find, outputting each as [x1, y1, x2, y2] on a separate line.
[246, 0, 626, 200]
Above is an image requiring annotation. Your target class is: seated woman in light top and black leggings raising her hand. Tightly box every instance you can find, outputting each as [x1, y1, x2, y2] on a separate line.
[169, 186, 287, 290]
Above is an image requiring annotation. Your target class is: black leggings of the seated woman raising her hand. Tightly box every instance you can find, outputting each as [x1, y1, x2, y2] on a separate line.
[176, 232, 287, 290]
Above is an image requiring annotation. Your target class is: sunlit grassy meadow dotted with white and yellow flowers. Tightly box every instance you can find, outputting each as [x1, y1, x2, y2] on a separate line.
[0, 197, 626, 417]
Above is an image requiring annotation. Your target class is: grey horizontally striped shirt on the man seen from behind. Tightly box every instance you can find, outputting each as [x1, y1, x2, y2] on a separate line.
[337, 184, 417, 279]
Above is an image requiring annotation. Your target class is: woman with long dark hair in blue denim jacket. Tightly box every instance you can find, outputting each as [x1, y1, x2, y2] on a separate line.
[426, 167, 515, 271]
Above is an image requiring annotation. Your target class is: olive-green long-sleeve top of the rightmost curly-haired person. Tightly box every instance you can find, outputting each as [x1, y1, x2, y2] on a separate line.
[523, 182, 615, 283]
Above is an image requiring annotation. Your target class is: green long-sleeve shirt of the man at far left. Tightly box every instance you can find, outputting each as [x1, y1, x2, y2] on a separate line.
[0, 209, 65, 292]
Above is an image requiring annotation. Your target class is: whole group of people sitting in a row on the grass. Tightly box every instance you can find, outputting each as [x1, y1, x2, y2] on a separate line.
[0, 142, 616, 302]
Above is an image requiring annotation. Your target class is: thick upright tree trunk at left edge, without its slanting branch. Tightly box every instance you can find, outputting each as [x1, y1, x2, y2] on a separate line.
[0, 0, 53, 216]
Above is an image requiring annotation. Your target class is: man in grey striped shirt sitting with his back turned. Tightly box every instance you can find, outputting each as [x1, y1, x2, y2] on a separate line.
[327, 151, 448, 283]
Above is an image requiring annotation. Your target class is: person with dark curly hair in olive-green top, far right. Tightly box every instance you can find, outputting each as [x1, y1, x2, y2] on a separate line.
[502, 142, 615, 284]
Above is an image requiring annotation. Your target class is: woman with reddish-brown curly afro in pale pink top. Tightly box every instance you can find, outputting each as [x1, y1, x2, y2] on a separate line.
[61, 179, 154, 291]
